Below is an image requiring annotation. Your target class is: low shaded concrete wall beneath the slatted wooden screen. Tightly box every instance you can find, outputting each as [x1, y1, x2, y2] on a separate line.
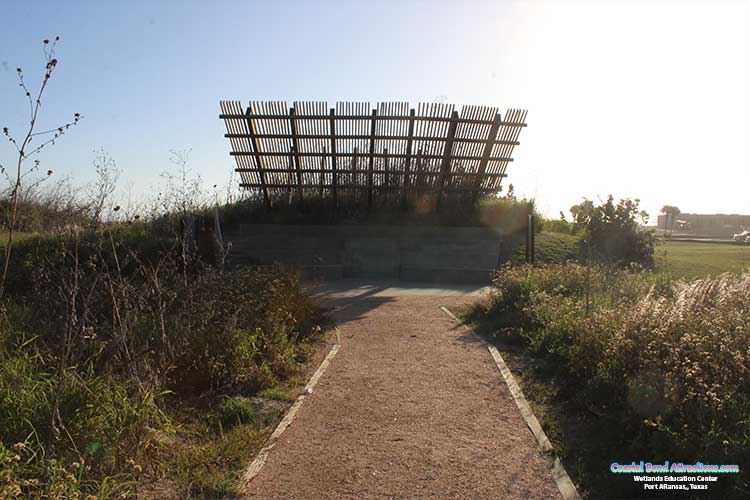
[224, 224, 508, 283]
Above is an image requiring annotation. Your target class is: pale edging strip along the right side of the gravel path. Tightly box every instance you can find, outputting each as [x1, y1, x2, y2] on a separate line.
[440, 307, 581, 500]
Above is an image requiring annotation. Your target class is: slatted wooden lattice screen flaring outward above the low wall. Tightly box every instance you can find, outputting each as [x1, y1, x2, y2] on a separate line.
[219, 101, 527, 207]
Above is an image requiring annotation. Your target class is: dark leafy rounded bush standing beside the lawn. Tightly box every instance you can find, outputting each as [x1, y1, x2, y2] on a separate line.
[570, 195, 655, 267]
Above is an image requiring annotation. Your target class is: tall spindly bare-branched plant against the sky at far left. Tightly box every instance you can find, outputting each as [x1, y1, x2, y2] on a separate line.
[0, 36, 81, 297]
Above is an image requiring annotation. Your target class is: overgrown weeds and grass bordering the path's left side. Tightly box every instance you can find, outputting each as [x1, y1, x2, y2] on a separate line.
[0, 228, 324, 500]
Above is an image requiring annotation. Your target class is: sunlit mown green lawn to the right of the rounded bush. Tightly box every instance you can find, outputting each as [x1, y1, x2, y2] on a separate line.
[654, 241, 750, 279]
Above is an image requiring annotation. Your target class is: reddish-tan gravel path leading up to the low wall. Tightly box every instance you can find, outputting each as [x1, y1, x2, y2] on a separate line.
[248, 286, 561, 500]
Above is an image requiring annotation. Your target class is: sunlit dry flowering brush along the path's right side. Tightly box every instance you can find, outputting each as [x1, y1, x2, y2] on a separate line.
[478, 264, 750, 498]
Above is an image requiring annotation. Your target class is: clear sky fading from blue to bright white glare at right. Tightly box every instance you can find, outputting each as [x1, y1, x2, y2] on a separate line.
[0, 0, 750, 219]
